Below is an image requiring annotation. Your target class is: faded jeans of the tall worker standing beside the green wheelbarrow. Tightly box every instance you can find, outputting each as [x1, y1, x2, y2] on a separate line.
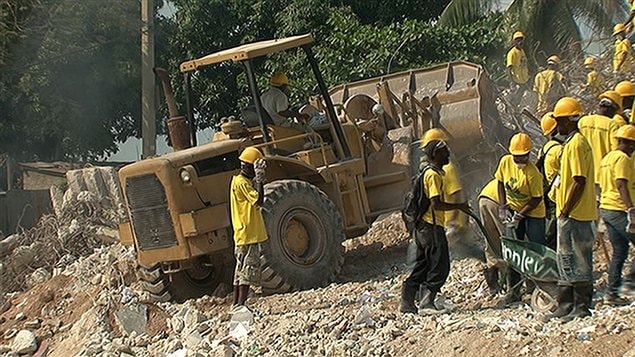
[557, 218, 595, 285]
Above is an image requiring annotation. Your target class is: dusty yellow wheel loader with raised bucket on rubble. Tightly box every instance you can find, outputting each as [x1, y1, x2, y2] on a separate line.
[119, 34, 510, 300]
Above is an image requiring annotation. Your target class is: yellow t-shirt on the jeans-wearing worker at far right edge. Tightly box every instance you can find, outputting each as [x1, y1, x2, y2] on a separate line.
[600, 150, 635, 211]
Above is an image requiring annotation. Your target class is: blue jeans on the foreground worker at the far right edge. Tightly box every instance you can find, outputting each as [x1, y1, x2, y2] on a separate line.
[600, 209, 635, 293]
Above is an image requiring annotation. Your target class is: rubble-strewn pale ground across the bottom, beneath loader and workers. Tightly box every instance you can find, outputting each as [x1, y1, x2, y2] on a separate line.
[0, 214, 635, 356]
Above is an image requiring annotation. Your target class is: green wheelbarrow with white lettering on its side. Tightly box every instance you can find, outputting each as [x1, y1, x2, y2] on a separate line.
[466, 211, 558, 313]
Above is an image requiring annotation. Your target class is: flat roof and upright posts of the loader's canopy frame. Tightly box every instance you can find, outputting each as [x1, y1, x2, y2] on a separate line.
[179, 34, 351, 159]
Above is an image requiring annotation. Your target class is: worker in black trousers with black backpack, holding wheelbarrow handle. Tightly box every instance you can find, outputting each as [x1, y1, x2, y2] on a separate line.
[399, 140, 469, 314]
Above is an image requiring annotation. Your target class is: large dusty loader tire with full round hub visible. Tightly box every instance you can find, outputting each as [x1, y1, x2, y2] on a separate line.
[261, 180, 345, 293]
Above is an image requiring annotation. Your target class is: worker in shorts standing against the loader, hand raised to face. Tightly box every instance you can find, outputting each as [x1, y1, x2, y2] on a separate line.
[229, 147, 268, 306]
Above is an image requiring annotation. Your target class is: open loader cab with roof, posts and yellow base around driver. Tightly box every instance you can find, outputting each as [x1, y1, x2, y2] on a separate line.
[180, 34, 357, 167]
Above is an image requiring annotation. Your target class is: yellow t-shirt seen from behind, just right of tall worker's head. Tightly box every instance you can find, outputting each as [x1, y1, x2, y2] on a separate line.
[578, 114, 619, 184]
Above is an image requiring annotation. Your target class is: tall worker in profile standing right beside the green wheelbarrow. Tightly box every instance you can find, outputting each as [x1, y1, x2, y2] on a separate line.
[544, 97, 598, 322]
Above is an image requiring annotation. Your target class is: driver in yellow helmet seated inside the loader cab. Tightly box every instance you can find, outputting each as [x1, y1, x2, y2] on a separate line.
[260, 72, 309, 130]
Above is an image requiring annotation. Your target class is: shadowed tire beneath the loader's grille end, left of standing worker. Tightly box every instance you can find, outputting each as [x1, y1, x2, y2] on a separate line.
[137, 252, 233, 302]
